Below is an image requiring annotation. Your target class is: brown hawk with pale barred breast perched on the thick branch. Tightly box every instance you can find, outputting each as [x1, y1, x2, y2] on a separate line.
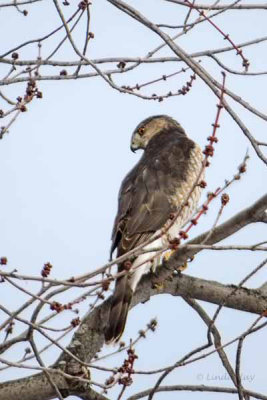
[105, 115, 203, 343]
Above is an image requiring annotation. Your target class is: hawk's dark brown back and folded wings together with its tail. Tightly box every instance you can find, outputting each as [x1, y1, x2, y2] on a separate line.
[105, 132, 194, 343]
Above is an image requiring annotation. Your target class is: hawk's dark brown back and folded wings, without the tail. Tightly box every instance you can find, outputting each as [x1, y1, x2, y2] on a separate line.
[111, 137, 194, 255]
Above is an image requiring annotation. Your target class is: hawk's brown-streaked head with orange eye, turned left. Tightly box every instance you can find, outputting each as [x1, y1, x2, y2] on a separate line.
[131, 115, 185, 152]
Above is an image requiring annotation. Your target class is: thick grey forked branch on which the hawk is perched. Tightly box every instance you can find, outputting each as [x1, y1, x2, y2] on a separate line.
[0, 195, 267, 400]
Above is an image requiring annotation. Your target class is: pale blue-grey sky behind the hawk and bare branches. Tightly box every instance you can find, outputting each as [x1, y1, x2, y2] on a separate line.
[0, 0, 267, 400]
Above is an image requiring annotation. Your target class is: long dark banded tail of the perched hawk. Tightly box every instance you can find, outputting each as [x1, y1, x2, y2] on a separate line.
[105, 276, 133, 343]
